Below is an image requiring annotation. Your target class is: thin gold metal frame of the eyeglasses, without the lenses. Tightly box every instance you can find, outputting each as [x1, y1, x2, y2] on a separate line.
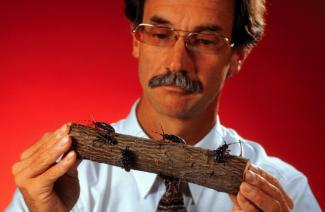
[131, 23, 235, 53]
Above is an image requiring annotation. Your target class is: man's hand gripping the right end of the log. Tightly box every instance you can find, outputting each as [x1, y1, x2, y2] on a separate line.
[230, 165, 293, 212]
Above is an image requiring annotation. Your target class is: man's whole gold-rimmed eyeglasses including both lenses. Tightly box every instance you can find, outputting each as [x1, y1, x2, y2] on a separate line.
[132, 23, 234, 54]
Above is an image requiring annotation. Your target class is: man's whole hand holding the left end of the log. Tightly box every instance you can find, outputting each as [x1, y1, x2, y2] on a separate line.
[12, 124, 80, 211]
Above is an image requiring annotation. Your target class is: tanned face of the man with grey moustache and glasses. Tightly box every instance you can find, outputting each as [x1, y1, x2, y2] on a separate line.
[133, 0, 238, 118]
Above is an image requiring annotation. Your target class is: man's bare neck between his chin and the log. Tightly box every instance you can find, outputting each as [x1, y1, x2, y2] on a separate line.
[136, 97, 219, 145]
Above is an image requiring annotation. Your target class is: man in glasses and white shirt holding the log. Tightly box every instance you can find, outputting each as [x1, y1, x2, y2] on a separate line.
[8, 0, 320, 211]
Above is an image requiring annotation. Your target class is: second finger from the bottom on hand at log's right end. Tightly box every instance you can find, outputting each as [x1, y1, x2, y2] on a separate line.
[240, 182, 289, 211]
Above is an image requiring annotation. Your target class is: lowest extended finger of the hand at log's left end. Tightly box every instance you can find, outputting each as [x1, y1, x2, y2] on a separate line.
[37, 150, 77, 185]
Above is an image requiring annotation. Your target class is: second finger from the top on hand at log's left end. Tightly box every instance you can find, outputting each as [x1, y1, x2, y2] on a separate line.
[21, 136, 71, 178]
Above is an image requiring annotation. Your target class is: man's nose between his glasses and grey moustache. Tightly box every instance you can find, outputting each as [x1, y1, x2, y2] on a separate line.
[165, 36, 193, 73]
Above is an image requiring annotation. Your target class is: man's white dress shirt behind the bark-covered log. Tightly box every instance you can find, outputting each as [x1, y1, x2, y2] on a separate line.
[7, 103, 321, 212]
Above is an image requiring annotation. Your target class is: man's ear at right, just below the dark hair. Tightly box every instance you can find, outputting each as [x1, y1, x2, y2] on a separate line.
[227, 48, 251, 79]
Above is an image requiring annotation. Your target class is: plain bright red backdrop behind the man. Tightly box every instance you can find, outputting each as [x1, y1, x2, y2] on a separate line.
[0, 0, 325, 210]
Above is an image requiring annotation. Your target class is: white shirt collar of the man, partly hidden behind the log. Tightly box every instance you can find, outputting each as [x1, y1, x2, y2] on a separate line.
[123, 100, 224, 203]
